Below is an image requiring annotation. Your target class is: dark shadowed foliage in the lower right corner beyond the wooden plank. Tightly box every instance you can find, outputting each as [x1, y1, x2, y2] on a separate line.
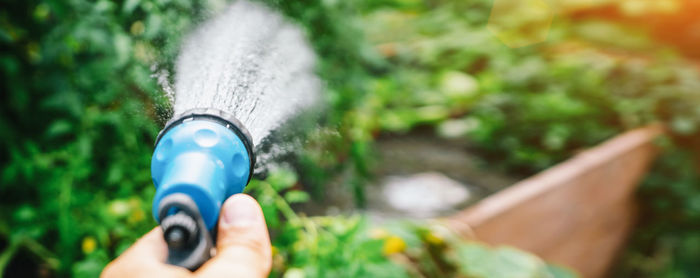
[616, 147, 700, 277]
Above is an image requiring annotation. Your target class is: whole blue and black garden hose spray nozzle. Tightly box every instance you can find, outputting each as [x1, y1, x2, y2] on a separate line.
[151, 109, 255, 270]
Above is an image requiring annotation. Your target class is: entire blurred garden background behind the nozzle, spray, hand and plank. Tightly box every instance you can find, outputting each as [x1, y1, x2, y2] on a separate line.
[0, 0, 700, 277]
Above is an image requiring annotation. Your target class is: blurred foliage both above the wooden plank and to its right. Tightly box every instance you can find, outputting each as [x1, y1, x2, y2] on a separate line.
[356, 1, 700, 277]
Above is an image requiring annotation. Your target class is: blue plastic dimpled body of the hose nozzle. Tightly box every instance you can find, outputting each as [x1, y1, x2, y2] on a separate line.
[151, 119, 252, 231]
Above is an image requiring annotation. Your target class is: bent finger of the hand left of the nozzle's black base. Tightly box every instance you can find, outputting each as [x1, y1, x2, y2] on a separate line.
[101, 227, 190, 278]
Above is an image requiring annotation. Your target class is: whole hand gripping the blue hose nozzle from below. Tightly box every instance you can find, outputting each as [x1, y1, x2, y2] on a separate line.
[102, 194, 272, 278]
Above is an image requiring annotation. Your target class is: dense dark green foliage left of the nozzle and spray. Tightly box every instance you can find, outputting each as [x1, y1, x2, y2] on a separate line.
[0, 1, 208, 277]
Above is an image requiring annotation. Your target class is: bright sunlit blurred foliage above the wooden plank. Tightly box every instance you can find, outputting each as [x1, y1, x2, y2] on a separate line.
[356, 1, 700, 175]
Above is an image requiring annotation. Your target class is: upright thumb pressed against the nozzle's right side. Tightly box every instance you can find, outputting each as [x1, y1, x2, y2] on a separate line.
[197, 194, 272, 278]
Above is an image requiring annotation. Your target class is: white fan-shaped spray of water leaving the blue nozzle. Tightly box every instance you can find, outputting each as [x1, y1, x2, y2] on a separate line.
[174, 0, 320, 148]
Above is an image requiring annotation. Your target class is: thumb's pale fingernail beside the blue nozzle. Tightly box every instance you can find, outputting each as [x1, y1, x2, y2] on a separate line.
[222, 194, 260, 227]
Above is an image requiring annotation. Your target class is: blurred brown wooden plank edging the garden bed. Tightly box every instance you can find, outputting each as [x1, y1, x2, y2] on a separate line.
[446, 125, 663, 277]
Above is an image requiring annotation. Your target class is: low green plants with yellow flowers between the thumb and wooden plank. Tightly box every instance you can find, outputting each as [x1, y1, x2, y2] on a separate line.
[247, 167, 578, 278]
